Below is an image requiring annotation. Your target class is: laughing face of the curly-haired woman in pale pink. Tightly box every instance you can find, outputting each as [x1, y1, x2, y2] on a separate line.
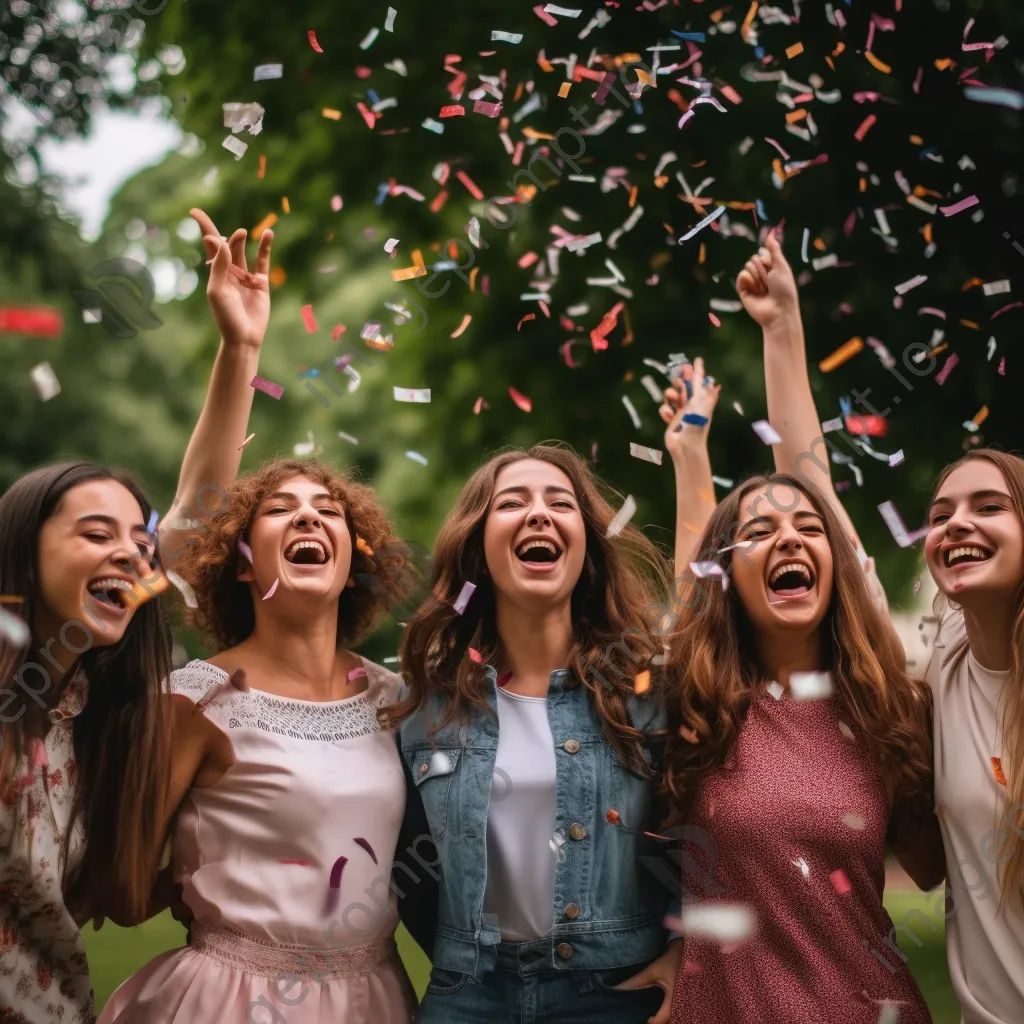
[239, 476, 352, 600]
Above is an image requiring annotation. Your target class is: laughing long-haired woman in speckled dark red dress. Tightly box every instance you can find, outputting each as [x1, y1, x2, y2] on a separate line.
[666, 234, 941, 1024]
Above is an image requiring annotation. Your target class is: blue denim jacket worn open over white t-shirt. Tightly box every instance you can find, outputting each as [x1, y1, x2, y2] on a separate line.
[399, 667, 672, 980]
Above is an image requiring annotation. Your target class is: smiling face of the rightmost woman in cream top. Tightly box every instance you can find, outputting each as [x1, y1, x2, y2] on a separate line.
[925, 459, 1024, 606]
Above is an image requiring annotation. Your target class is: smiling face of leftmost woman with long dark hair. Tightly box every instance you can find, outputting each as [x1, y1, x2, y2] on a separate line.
[34, 480, 154, 646]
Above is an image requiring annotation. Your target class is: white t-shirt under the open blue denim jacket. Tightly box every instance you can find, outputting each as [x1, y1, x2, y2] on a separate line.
[483, 687, 558, 942]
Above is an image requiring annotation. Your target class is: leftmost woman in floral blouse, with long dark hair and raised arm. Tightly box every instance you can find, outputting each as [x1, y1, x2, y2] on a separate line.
[0, 210, 270, 1024]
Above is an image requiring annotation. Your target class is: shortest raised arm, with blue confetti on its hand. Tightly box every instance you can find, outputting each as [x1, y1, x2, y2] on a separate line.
[658, 357, 722, 600]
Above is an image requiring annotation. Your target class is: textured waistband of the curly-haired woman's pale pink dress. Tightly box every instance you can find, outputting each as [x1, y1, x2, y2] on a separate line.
[190, 922, 395, 980]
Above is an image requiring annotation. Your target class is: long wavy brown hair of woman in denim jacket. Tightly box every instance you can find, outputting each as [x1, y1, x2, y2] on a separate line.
[381, 444, 669, 771]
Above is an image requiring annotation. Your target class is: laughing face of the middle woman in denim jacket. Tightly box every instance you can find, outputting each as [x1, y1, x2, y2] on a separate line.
[483, 459, 587, 610]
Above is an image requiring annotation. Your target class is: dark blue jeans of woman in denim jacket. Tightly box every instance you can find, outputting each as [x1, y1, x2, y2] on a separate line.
[416, 942, 665, 1024]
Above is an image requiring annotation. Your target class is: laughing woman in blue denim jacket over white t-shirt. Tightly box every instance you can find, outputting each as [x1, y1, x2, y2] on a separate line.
[385, 392, 714, 1024]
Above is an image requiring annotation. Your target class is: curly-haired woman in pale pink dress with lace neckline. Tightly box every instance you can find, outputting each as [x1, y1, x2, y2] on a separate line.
[100, 459, 425, 1024]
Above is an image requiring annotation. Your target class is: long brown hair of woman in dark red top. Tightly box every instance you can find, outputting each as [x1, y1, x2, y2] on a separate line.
[664, 473, 931, 825]
